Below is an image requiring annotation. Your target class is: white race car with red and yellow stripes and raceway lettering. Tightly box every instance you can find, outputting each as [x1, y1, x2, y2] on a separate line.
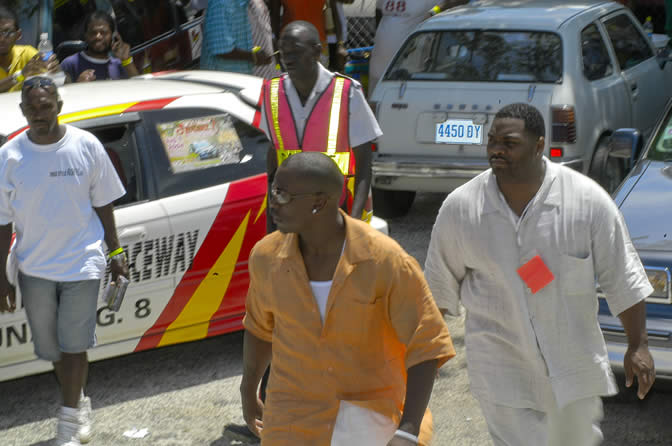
[0, 71, 387, 381]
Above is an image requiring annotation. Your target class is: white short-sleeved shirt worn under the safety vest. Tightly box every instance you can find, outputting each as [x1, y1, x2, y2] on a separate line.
[259, 63, 383, 148]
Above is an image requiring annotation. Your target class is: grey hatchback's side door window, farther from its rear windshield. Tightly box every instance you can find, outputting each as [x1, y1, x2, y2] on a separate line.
[604, 14, 653, 70]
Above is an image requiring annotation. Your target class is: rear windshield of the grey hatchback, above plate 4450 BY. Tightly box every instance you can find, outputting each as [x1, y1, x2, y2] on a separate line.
[384, 30, 562, 83]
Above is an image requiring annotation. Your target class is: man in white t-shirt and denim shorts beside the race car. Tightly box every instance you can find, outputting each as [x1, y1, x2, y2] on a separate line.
[0, 77, 128, 446]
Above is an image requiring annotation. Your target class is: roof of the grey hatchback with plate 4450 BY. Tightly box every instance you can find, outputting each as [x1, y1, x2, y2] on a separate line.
[419, 0, 624, 31]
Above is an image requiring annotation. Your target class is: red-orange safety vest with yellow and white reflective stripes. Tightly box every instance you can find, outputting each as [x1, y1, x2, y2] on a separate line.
[264, 74, 373, 221]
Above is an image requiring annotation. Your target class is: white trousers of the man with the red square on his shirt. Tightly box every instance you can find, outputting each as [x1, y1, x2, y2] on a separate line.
[479, 397, 604, 446]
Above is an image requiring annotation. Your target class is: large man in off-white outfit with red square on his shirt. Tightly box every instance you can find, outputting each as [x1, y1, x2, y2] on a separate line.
[425, 104, 655, 446]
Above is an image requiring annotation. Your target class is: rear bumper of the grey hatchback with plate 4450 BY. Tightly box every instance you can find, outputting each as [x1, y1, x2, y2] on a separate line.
[372, 157, 584, 192]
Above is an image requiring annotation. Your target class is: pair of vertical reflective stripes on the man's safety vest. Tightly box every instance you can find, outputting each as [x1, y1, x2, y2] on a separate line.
[270, 77, 350, 177]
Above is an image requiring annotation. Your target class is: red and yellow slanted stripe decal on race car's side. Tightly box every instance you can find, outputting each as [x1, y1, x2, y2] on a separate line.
[135, 174, 267, 351]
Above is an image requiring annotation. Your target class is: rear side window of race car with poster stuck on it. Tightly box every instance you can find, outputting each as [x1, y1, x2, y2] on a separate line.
[144, 109, 268, 197]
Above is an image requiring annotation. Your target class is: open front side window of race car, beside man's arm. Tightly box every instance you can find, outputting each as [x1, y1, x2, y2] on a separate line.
[86, 124, 145, 206]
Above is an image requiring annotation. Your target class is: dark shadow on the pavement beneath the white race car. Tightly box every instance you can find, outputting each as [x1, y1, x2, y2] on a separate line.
[0, 332, 243, 428]
